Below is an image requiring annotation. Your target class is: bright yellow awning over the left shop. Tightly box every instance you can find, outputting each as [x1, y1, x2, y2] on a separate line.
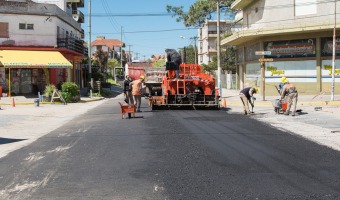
[0, 50, 72, 68]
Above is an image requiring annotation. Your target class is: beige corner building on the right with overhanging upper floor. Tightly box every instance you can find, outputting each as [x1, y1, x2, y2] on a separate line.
[221, 0, 340, 95]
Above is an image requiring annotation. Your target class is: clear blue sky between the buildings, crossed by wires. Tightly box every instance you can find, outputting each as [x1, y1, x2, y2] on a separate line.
[80, 0, 198, 60]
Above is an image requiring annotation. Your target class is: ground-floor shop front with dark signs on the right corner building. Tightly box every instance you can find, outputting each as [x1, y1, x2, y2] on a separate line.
[237, 37, 340, 95]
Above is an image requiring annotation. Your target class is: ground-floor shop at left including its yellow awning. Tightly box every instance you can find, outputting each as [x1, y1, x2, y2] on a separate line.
[0, 50, 72, 95]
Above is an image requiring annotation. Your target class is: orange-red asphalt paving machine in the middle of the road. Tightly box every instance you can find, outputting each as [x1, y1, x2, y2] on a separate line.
[149, 63, 219, 109]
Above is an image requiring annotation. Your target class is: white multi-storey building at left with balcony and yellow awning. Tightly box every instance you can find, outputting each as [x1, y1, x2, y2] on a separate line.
[0, 0, 87, 95]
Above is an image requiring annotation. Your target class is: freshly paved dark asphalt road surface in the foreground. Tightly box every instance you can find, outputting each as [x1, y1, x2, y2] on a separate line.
[0, 99, 340, 200]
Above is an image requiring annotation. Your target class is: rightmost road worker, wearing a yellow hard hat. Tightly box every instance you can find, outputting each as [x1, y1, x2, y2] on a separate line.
[281, 83, 298, 116]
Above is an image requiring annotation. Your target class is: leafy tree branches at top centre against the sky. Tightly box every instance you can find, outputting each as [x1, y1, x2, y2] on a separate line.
[166, 0, 235, 27]
